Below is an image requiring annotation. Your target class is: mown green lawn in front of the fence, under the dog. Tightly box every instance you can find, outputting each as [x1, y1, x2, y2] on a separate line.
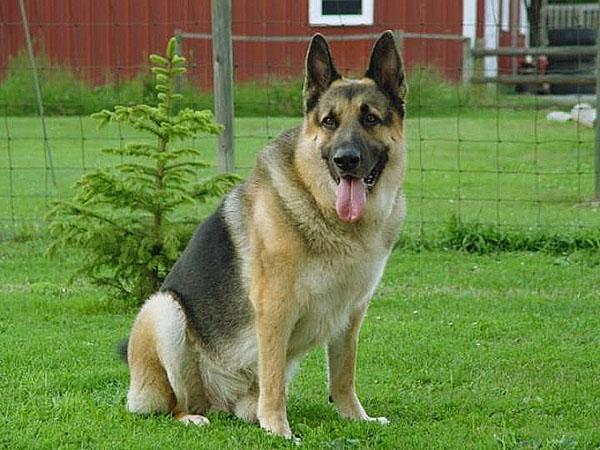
[0, 240, 600, 449]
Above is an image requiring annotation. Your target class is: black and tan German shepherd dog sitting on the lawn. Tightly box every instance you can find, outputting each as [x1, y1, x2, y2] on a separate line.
[126, 31, 406, 438]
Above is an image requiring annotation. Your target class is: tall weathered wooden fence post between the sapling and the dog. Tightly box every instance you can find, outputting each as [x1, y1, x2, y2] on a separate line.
[211, 0, 234, 172]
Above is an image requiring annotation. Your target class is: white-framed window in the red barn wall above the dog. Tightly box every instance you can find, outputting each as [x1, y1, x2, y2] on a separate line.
[308, 0, 374, 25]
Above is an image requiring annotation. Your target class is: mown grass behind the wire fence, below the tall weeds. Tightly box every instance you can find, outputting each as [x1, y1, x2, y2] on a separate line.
[0, 107, 600, 238]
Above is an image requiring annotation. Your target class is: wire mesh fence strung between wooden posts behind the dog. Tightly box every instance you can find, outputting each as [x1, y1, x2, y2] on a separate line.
[0, 0, 600, 241]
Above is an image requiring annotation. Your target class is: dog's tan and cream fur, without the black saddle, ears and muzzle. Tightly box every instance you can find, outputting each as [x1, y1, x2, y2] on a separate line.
[128, 31, 406, 437]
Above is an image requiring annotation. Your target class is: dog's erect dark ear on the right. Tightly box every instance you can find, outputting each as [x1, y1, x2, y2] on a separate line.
[365, 30, 407, 104]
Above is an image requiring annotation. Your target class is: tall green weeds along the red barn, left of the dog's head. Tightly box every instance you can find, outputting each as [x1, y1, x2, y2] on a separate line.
[0, 52, 302, 117]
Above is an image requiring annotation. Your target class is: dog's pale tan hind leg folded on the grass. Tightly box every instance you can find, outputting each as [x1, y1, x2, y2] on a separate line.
[127, 293, 208, 425]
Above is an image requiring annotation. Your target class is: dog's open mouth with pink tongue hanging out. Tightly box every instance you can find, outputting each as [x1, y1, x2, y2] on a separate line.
[335, 158, 386, 223]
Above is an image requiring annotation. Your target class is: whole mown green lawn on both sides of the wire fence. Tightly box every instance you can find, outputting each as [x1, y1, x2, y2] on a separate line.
[0, 109, 600, 449]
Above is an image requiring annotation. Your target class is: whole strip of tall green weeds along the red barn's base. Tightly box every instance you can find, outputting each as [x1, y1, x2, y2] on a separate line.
[0, 52, 539, 117]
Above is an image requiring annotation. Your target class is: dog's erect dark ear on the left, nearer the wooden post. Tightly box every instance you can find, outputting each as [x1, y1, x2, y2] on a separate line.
[304, 34, 341, 112]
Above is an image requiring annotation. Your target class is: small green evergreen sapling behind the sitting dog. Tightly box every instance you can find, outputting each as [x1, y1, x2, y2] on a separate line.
[48, 38, 239, 301]
